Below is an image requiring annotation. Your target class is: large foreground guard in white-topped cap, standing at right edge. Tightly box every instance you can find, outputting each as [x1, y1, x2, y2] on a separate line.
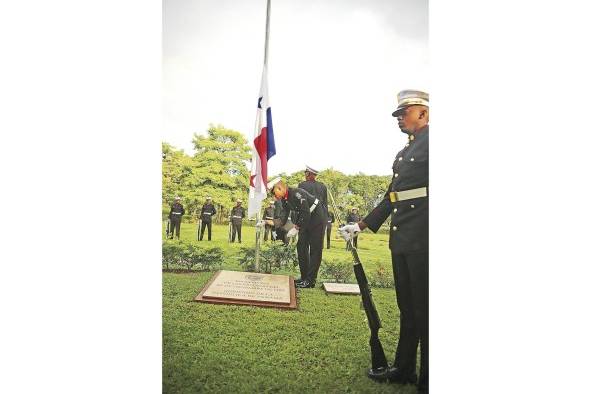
[340, 90, 429, 393]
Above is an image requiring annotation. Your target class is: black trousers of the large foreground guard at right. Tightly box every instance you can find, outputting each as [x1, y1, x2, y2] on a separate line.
[392, 251, 429, 385]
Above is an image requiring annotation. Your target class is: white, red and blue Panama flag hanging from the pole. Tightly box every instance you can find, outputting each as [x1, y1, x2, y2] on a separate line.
[248, 64, 275, 218]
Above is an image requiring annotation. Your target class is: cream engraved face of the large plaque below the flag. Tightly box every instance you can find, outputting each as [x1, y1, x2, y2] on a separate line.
[202, 271, 291, 304]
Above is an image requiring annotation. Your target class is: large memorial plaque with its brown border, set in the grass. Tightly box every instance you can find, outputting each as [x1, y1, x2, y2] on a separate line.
[195, 271, 297, 309]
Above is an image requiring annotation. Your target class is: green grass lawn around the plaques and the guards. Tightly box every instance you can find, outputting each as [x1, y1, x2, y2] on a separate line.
[162, 223, 416, 393]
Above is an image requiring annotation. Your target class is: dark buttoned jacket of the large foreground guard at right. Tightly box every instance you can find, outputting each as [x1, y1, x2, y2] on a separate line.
[363, 126, 429, 254]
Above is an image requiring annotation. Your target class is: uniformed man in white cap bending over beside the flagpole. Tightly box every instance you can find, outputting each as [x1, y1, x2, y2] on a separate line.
[268, 178, 326, 288]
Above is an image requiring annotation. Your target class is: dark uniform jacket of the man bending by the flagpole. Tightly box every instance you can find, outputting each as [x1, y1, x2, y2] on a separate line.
[280, 187, 326, 230]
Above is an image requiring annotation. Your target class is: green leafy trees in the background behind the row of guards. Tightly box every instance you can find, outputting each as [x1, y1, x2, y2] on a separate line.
[162, 125, 391, 222]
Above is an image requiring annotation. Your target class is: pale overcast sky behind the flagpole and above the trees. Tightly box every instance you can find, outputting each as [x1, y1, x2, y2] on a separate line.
[163, 0, 429, 175]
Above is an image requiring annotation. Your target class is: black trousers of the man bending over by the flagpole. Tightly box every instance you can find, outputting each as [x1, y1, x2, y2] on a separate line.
[297, 223, 325, 282]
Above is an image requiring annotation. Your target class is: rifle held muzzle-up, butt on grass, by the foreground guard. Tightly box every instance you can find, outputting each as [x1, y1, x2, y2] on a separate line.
[328, 191, 388, 370]
